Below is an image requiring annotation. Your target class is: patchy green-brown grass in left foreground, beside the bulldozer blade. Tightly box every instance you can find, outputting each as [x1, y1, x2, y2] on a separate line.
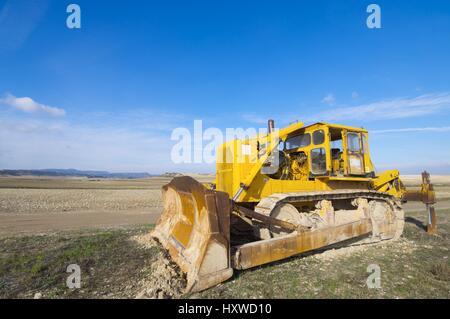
[0, 226, 158, 298]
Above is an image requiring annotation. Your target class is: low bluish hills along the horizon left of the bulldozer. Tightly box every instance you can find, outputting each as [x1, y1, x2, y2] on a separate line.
[0, 168, 155, 178]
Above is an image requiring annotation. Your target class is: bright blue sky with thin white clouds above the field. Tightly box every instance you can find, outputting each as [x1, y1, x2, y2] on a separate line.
[0, 0, 450, 173]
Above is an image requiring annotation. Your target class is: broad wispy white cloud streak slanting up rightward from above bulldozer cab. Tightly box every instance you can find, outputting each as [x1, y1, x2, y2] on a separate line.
[308, 93, 450, 121]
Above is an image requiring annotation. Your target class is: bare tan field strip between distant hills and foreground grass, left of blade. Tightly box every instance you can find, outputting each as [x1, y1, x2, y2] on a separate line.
[0, 175, 212, 236]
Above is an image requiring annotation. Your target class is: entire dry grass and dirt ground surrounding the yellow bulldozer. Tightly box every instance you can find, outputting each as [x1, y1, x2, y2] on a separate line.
[0, 176, 450, 298]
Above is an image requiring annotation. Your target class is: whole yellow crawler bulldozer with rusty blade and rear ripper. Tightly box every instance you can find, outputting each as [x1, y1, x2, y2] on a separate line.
[151, 120, 436, 292]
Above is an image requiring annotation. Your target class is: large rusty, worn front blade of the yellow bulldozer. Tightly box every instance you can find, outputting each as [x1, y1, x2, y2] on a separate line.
[151, 176, 233, 293]
